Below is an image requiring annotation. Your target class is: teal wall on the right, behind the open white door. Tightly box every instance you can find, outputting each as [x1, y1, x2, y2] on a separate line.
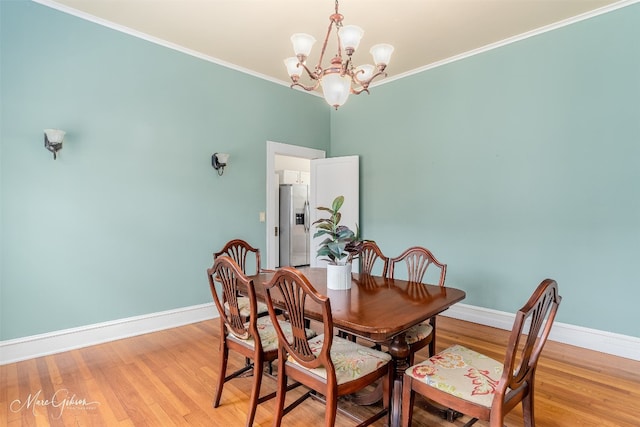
[331, 4, 640, 337]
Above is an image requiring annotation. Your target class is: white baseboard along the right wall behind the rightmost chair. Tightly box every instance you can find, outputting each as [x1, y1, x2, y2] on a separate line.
[442, 303, 640, 361]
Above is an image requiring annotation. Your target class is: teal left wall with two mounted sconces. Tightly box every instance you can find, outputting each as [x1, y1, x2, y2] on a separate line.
[0, 1, 330, 340]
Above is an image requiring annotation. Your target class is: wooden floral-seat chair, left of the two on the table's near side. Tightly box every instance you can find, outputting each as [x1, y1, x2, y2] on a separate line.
[207, 255, 316, 426]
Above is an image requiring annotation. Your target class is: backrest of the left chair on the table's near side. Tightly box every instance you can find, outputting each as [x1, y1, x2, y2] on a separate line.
[207, 255, 260, 343]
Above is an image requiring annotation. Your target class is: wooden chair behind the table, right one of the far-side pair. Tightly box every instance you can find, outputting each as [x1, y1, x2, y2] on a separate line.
[389, 246, 447, 365]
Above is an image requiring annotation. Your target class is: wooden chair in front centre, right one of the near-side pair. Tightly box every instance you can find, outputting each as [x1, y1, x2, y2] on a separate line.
[266, 267, 392, 427]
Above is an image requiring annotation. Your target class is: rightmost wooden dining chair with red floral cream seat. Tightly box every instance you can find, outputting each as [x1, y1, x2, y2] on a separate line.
[402, 279, 562, 427]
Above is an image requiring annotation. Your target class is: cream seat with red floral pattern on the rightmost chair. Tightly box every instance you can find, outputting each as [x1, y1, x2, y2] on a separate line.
[405, 345, 503, 408]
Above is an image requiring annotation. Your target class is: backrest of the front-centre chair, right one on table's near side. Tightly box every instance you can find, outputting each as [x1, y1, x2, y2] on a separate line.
[266, 267, 335, 372]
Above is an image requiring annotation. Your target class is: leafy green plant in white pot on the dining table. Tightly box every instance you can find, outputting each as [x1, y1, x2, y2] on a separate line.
[313, 196, 362, 289]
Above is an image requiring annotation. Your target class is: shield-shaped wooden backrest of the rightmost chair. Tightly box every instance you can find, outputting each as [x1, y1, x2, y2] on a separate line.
[494, 279, 562, 404]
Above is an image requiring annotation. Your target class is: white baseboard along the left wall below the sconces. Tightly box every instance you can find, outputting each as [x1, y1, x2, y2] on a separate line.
[0, 303, 218, 365]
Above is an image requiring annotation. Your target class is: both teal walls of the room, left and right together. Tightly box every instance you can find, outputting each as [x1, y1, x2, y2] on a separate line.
[0, 1, 640, 340]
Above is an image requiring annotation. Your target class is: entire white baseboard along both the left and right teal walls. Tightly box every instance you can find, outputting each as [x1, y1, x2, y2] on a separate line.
[0, 303, 640, 365]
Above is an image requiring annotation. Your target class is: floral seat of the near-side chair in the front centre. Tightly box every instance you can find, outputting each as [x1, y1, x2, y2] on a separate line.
[287, 334, 391, 384]
